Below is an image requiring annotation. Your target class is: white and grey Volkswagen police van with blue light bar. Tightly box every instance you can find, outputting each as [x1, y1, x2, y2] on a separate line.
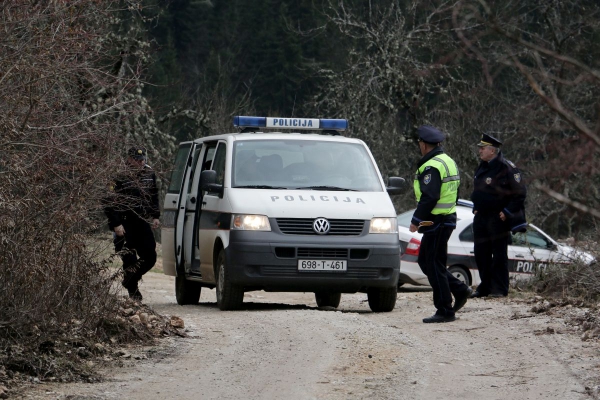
[161, 116, 404, 312]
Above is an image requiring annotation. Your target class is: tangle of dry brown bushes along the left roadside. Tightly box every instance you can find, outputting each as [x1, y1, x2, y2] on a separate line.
[0, 0, 176, 386]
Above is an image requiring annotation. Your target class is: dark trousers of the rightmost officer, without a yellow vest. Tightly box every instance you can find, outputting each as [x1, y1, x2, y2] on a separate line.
[473, 213, 510, 296]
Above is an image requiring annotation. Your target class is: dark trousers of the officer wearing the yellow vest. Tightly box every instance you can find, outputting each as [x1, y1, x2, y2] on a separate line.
[418, 225, 468, 317]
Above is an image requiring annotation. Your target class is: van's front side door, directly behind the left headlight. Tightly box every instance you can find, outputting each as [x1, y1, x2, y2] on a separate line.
[198, 141, 231, 281]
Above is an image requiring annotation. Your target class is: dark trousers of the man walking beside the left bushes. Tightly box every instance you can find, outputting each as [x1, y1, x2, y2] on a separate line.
[114, 218, 156, 291]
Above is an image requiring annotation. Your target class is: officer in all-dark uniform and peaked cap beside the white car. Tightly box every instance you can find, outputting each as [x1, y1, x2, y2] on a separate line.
[471, 134, 527, 297]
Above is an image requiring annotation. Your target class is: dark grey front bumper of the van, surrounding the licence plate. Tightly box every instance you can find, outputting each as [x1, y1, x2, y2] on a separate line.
[225, 231, 400, 293]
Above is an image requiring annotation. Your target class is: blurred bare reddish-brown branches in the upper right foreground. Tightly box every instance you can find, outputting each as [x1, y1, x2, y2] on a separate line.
[453, 0, 600, 235]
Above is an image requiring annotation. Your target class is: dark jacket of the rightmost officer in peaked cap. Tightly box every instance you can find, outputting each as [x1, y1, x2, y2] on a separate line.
[471, 152, 527, 232]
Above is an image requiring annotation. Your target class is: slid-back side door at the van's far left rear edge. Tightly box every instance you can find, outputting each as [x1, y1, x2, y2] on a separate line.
[161, 142, 195, 276]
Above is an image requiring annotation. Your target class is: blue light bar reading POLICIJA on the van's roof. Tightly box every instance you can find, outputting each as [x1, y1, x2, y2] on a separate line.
[233, 116, 348, 131]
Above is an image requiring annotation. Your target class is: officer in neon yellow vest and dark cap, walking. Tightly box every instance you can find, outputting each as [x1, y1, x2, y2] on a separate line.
[409, 125, 472, 323]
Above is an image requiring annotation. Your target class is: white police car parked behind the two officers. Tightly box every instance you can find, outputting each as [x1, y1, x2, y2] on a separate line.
[398, 200, 594, 286]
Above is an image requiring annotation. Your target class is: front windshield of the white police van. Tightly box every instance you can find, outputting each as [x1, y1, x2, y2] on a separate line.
[231, 139, 383, 192]
